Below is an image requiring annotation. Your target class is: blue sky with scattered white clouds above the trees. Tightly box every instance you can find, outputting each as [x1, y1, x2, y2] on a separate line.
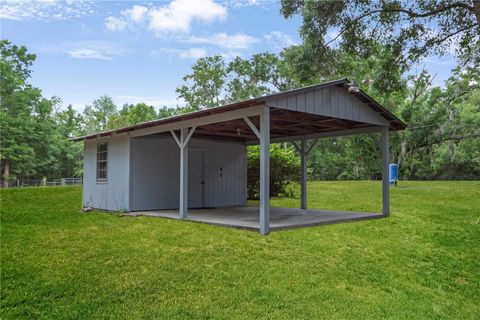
[0, 0, 455, 110]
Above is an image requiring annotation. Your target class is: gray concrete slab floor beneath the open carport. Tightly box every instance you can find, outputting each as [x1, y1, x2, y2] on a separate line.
[124, 207, 386, 231]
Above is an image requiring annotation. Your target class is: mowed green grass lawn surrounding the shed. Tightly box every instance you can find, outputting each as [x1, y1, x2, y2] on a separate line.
[0, 181, 480, 319]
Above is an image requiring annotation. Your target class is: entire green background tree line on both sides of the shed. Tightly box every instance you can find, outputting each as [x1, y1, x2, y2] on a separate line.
[0, 0, 480, 184]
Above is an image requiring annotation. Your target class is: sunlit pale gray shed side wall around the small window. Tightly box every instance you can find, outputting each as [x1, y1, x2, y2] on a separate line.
[83, 135, 130, 211]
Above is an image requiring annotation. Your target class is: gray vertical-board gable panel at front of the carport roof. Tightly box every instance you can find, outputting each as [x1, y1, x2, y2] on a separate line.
[266, 87, 388, 126]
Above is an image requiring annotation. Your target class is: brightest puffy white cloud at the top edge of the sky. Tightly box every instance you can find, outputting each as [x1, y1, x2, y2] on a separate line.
[105, 0, 227, 37]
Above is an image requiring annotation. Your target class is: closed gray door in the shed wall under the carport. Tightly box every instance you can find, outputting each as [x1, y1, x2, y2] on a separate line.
[188, 148, 205, 208]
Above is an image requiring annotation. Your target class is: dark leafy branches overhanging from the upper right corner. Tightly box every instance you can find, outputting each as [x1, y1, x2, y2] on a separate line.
[281, 0, 480, 88]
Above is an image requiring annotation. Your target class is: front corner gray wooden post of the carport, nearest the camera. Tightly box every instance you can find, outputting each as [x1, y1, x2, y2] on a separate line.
[260, 107, 270, 235]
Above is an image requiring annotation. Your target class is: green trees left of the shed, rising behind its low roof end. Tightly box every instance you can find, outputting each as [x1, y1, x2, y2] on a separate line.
[0, 40, 190, 180]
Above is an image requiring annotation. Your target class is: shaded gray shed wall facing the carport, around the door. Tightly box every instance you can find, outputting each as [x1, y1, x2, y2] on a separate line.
[130, 137, 247, 210]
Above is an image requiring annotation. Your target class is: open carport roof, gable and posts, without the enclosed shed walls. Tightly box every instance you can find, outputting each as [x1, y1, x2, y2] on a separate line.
[75, 79, 406, 235]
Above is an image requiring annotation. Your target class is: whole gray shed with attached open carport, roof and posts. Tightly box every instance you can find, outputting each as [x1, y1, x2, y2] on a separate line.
[72, 79, 406, 234]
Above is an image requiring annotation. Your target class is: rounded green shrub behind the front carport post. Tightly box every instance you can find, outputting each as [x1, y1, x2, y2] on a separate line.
[247, 144, 300, 199]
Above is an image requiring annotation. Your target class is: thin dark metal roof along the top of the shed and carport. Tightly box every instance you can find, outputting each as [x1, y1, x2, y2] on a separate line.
[70, 78, 407, 141]
